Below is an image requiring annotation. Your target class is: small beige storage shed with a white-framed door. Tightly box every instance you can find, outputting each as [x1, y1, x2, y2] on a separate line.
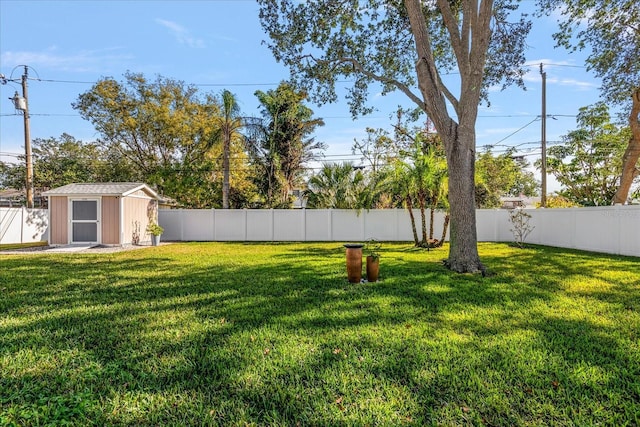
[43, 182, 158, 246]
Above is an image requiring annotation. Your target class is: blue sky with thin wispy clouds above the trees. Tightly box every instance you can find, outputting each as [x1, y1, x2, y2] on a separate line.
[0, 0, 600, 190]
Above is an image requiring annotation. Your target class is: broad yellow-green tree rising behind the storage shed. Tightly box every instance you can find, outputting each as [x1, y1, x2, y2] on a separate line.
[74, 73, 210, 189]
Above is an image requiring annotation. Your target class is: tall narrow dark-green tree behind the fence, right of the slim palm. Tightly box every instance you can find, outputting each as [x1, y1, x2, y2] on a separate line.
[251, 82, 325, 207]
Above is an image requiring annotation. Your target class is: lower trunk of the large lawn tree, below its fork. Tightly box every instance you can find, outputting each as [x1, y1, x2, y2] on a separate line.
[443, 126, 484, 273]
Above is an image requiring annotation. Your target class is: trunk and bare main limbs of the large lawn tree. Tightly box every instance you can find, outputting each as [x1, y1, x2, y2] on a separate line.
[404, 0, 494, 273]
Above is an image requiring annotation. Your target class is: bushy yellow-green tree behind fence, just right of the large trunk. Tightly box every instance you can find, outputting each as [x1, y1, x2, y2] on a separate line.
[476, 149, 538, 208]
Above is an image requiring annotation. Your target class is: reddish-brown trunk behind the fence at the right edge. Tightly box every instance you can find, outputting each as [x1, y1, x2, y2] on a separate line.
[613, 88, 640, 204]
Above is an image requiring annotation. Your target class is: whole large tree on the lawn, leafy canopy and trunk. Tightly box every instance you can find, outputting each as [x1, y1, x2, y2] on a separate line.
[258, 0, 530, 272]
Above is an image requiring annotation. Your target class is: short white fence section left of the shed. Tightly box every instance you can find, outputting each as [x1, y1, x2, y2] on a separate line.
[0, 207, 49, 244]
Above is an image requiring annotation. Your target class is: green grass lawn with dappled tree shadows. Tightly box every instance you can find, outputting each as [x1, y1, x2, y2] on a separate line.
[0, 243, 640, 426]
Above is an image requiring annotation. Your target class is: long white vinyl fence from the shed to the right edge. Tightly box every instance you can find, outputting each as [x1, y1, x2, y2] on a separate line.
[159, 206, 640, 256]
